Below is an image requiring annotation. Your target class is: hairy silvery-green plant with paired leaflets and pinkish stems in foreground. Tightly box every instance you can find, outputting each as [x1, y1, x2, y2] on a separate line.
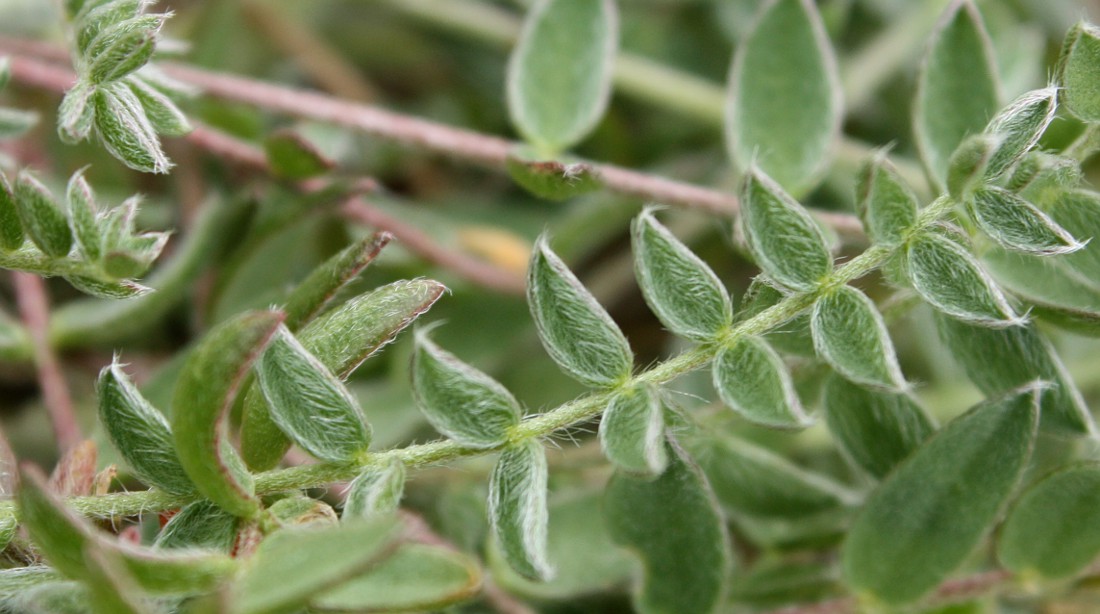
[0, 0, 1100, 614]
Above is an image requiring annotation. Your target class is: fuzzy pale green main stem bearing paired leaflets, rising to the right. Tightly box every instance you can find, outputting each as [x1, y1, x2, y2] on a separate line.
[0, 191, 954, 525]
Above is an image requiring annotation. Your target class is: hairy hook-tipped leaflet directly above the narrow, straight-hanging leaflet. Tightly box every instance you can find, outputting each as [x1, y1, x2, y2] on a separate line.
[413, 330, 523, 448]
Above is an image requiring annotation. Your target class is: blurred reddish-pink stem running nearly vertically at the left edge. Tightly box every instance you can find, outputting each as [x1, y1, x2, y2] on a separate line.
[12, 272, 84, 452]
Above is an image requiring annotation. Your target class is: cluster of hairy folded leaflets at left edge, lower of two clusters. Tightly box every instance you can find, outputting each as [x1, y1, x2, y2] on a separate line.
[0, 169, 168, 298]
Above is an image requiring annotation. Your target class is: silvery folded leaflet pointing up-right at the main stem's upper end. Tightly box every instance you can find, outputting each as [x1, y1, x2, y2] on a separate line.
[986, 87, 1058, 178]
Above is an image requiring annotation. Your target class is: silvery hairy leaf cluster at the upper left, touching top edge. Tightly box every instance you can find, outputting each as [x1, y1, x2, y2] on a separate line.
[57, 0, 190, 173]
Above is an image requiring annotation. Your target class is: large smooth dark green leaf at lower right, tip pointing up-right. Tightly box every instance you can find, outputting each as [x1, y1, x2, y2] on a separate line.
[840, 386, 1040, 604]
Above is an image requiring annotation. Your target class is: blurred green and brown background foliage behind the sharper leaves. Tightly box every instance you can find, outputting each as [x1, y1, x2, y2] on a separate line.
[0, 0, 1100, 612]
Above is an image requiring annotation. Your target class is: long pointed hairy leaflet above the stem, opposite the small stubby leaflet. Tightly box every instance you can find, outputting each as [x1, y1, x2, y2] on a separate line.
[527, 235, 634, 387]
